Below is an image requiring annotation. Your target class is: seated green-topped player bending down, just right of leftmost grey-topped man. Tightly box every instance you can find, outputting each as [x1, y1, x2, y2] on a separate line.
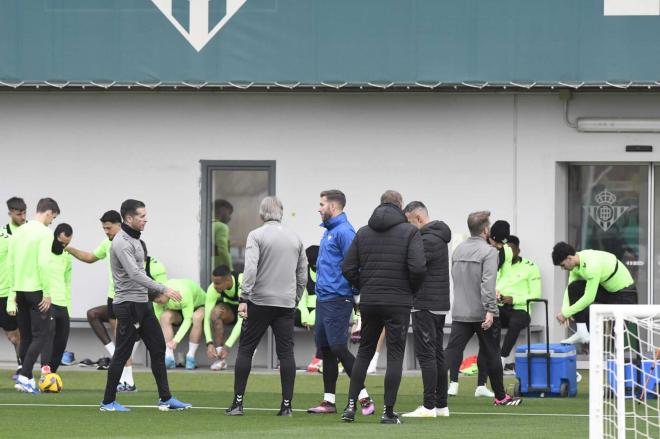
[154, 279, 206, 370]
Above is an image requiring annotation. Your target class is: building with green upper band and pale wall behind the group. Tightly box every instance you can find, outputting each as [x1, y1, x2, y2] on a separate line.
[0, 0, 660, 368]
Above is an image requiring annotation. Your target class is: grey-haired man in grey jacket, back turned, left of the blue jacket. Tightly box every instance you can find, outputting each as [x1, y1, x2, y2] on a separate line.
[226, 197, 307, 416]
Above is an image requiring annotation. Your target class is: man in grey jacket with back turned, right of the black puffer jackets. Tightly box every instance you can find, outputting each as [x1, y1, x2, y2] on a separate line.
[443, 211, 522, 406]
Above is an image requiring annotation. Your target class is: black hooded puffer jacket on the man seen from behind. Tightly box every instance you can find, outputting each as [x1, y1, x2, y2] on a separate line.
[342, 203, 426, 308]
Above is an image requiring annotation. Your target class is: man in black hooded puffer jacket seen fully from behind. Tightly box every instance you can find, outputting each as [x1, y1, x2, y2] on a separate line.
[342, 191, 426, 424]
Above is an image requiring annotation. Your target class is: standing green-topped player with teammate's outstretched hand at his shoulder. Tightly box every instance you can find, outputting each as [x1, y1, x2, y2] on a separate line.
[41, 223, 73, 375]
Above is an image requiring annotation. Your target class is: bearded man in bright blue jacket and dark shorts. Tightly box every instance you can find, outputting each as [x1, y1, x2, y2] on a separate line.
[307, 189, 374, 415]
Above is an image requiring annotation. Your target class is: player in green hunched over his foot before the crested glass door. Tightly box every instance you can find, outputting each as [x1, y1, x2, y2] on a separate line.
[552, 242, 637, 343]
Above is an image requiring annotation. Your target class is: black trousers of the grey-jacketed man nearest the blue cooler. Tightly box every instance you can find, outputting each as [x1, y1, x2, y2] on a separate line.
[445, 317, 506, 399]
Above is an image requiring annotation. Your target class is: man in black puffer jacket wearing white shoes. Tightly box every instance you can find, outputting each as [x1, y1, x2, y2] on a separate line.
[403, 201, 451, 418]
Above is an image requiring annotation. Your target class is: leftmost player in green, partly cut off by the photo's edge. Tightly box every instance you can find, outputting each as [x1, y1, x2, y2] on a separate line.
[0, 197, 27, 374]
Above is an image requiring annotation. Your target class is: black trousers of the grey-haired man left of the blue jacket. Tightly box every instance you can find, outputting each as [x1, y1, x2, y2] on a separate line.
[234, 302, 296, 401]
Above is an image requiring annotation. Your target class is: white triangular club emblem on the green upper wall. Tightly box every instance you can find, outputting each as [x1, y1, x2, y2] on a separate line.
[151, 0, 247, 52]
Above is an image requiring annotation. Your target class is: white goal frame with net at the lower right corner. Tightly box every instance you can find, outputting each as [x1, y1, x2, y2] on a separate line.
[589, 305, 660, 439]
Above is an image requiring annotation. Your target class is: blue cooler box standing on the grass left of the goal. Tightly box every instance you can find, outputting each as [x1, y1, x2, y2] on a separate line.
[516, 343, 577, 396]
